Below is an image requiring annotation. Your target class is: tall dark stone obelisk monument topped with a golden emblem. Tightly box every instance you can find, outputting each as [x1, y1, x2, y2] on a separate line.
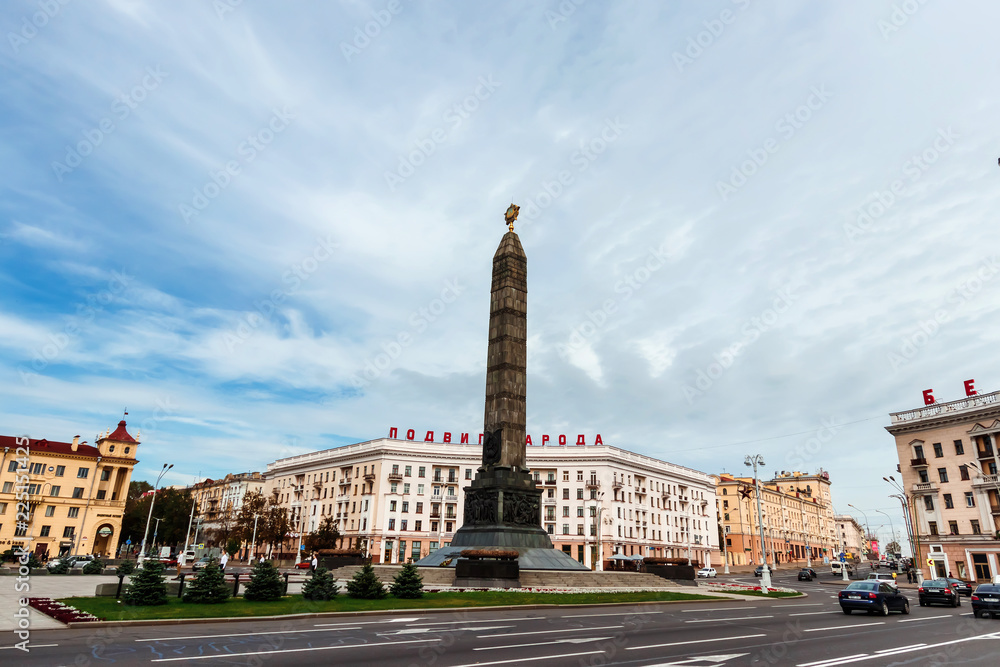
[417, 204, 588, 570]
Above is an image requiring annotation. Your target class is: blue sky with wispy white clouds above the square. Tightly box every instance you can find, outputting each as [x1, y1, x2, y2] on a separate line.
[0, 0, 1000, 552]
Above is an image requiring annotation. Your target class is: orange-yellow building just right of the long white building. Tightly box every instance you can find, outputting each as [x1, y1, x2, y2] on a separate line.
[713, 470, 839, 565]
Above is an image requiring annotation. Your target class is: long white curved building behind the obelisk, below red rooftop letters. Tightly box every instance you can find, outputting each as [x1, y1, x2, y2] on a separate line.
[266, 438, 718, 567]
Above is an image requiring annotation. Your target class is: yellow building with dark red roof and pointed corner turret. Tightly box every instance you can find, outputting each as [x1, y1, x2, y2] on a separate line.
[0, 420, 139, 557]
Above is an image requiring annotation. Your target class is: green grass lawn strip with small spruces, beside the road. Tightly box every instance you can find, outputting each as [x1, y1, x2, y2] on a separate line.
[60, 591, 721, 621]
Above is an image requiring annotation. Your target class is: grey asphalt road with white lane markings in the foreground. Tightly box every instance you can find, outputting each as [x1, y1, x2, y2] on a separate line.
[7, 573, 1000, 667]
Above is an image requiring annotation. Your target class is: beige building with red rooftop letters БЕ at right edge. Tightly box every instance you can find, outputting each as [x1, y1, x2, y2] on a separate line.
[886, 388, 1000, 582]
